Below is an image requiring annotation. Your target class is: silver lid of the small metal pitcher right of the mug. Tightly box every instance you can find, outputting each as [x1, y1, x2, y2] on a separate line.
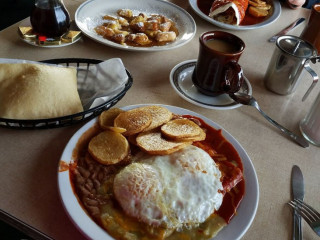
[277, 35, 316, 58]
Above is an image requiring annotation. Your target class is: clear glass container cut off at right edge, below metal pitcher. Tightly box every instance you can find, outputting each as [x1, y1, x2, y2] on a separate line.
[300, 90, 320, 147]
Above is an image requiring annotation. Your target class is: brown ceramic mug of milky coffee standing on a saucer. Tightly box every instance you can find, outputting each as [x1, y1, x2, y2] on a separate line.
[192, 31, 245, 96]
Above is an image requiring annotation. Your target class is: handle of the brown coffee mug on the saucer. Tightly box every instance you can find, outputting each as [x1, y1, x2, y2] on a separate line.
[221, 61, 244, 93]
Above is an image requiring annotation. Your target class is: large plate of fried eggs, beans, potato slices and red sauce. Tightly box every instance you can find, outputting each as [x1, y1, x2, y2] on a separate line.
[58, 105, 259, 240]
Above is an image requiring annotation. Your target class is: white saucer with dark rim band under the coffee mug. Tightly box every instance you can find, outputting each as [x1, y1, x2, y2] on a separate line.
[170, 59, 252, 110]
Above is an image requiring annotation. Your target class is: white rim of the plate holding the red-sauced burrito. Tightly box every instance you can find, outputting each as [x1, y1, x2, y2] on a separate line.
[189, 0, 281, 30]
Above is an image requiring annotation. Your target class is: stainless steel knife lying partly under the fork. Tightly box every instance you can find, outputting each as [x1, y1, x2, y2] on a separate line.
[291, 165, 304, 240]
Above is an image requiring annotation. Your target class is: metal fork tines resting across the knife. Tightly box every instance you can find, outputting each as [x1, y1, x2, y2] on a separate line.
[288, 199, 320, 237]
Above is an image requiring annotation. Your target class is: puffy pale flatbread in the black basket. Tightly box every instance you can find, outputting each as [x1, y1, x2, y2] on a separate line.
[0, 63, 83, 119]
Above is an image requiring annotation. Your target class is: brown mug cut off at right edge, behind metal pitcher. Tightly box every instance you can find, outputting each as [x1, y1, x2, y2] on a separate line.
[300, 4, 320, 54]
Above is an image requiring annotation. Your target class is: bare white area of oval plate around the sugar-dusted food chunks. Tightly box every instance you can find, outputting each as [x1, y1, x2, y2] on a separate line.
[75, 0, 196, 51]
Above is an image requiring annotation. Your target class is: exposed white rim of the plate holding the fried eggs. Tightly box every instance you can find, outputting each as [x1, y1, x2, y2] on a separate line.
[58, 104, 259, 240]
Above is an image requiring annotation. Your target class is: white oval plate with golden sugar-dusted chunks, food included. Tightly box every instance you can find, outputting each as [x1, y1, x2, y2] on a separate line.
[75, 0, 196, 51]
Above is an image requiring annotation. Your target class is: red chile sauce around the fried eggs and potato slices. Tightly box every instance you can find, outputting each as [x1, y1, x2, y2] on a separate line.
[66, 115, 245, 232]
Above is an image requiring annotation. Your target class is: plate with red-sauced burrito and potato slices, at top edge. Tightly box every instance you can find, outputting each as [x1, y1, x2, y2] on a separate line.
[189, 0, 281, 30]
